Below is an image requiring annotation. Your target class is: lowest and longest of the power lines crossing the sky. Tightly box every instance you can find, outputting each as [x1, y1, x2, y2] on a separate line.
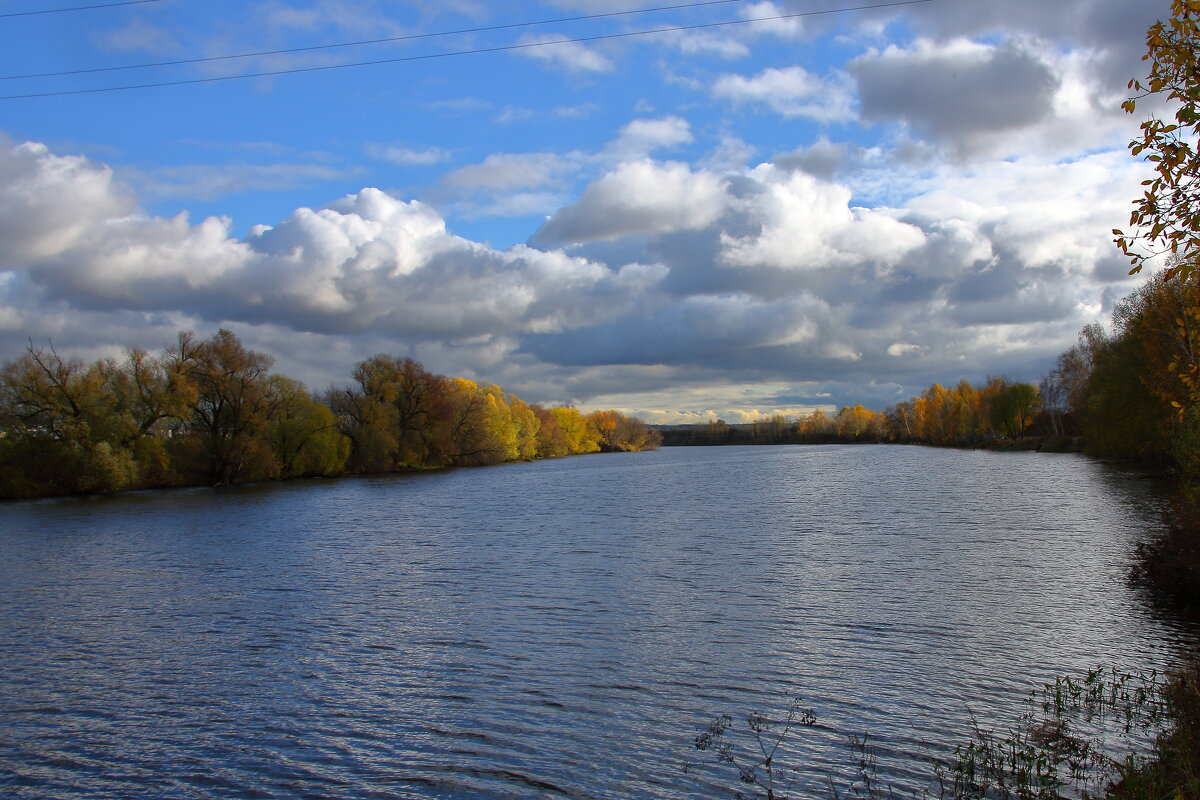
[0, 0, 937, 101]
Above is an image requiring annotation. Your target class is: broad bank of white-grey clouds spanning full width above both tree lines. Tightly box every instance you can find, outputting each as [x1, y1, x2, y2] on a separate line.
[0, 137, 1146, 415]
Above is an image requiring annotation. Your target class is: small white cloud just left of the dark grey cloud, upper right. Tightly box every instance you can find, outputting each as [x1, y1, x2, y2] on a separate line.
[712, 67, 854, 122]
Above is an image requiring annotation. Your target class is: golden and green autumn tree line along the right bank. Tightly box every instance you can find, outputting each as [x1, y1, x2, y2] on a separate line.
[665, 271, 1200, 476]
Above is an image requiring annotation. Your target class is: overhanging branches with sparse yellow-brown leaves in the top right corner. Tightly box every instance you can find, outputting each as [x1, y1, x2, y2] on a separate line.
[1112, 0, 1200, 277]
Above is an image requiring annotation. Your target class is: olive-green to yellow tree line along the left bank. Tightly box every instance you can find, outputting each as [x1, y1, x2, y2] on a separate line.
[0, 330, 659, 498]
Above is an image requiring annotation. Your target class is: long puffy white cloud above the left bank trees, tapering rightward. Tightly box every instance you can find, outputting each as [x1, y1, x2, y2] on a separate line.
[0, 145, 661, 350]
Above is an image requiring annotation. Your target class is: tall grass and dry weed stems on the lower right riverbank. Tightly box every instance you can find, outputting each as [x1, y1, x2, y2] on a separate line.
[692, 662, 1200, 800]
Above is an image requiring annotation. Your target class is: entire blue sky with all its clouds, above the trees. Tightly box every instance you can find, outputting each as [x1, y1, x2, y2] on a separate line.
[0, 0, 1169, 422]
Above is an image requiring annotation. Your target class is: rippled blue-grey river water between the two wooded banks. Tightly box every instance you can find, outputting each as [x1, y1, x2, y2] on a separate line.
[0, 446, 1194, 800]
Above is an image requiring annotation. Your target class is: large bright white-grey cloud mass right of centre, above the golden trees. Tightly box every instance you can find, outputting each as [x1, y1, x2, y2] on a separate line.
[530, 143, 1145, 404]
